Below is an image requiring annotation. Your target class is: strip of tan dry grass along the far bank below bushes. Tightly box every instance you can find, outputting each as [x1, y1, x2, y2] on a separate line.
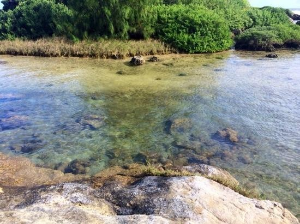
[0, 38, 175, 59]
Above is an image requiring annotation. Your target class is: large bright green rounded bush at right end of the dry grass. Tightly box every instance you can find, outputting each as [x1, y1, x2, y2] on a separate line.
[156, 5, 232, 53]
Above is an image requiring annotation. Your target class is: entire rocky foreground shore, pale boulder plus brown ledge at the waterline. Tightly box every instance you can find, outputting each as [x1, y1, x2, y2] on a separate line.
[0, 153, 299, 224]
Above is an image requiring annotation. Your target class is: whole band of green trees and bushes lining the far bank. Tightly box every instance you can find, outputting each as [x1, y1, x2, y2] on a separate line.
[0, 0, 300, 53]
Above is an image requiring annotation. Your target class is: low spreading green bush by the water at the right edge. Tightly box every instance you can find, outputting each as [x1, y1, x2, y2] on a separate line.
[235, 25, 300, 51]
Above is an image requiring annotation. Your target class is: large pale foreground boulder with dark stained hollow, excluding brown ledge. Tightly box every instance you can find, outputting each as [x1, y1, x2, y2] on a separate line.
[0, 176, 299, 224]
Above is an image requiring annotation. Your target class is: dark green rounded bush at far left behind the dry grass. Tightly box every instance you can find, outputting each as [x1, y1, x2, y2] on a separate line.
[0, 0, 71, 39]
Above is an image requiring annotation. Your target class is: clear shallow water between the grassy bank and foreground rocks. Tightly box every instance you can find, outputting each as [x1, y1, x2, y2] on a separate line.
[0, 51, 300, 215]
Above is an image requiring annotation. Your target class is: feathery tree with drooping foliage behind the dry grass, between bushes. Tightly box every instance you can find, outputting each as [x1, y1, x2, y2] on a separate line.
[67, 0, 160, 39]
